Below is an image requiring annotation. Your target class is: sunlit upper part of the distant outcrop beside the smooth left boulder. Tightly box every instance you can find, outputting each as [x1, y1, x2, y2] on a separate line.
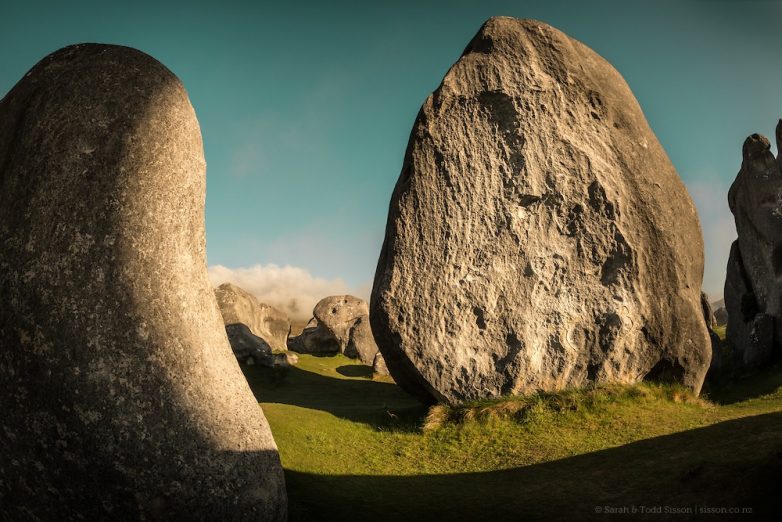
[215, 283, 291, 357]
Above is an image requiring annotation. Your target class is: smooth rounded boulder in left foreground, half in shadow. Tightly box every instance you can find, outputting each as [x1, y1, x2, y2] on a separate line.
[0, 44, 287, 520]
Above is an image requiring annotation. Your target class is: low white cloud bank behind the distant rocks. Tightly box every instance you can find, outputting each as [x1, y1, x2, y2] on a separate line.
[209, 264, 372, 321]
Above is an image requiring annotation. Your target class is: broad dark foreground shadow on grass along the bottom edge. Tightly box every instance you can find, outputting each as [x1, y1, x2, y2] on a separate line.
[286, 413, 782, 522]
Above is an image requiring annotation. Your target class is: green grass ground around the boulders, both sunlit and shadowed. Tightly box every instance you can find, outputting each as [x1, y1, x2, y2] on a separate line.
[243, 355, 782, 521]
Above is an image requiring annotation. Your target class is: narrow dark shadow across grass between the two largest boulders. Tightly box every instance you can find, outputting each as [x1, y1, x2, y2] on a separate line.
[242, 365, 427, 431]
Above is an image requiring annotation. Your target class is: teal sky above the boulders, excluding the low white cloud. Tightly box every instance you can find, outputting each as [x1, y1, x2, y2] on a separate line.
[0, 0, 782, 297]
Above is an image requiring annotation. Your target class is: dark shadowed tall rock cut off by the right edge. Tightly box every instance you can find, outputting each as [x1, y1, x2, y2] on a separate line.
[725, 127, 782, 369]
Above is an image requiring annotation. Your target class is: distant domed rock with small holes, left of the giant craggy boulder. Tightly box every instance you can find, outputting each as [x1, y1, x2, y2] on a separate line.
[288, 295, 378, 365]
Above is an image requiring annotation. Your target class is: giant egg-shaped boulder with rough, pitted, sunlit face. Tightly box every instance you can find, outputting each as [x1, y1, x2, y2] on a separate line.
[370, 18, 711, 403]
